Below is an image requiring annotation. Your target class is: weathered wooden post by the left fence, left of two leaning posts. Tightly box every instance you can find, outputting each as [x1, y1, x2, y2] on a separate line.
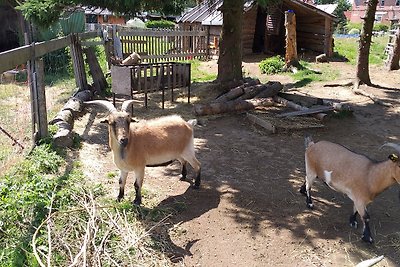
[70, 34, 87, 91]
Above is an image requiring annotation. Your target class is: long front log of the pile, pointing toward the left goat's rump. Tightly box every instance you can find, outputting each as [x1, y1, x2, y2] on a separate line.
[193, 98, 274, 116]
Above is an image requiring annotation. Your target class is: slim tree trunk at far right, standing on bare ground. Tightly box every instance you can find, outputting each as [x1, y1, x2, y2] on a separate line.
[355, 0, 378, 88]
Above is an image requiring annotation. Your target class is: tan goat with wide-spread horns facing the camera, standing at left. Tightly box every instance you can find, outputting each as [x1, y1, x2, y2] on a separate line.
[85, 100, 201, 205]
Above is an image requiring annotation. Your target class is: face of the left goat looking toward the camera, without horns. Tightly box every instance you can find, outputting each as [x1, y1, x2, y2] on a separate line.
[103, 111, 132, 148]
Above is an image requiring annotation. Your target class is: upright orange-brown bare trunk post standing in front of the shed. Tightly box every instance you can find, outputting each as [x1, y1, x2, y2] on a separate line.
[285, 11, 299, 69]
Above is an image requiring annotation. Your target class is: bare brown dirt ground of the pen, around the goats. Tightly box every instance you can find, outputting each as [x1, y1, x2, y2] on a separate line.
[75, 60, 400, 266]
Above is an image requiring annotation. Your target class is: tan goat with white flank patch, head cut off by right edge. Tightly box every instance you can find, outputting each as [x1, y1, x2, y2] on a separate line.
[300, 136, 400, 243]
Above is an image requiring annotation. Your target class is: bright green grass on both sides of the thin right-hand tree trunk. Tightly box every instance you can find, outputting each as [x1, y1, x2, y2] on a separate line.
[334, 36, 388, 65]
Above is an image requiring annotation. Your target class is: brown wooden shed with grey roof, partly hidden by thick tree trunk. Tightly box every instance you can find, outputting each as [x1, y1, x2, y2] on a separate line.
[178, 0, 336, 56]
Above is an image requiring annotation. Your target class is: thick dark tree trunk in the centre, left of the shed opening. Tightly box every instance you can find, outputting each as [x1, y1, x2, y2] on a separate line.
[218, 0, 243, 83]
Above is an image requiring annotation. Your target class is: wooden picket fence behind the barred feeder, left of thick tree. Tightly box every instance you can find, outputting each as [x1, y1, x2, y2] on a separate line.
[112, 26, 210, 62]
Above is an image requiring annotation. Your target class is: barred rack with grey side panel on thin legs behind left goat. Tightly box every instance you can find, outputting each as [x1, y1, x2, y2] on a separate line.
[111, 62, 191, 109]
